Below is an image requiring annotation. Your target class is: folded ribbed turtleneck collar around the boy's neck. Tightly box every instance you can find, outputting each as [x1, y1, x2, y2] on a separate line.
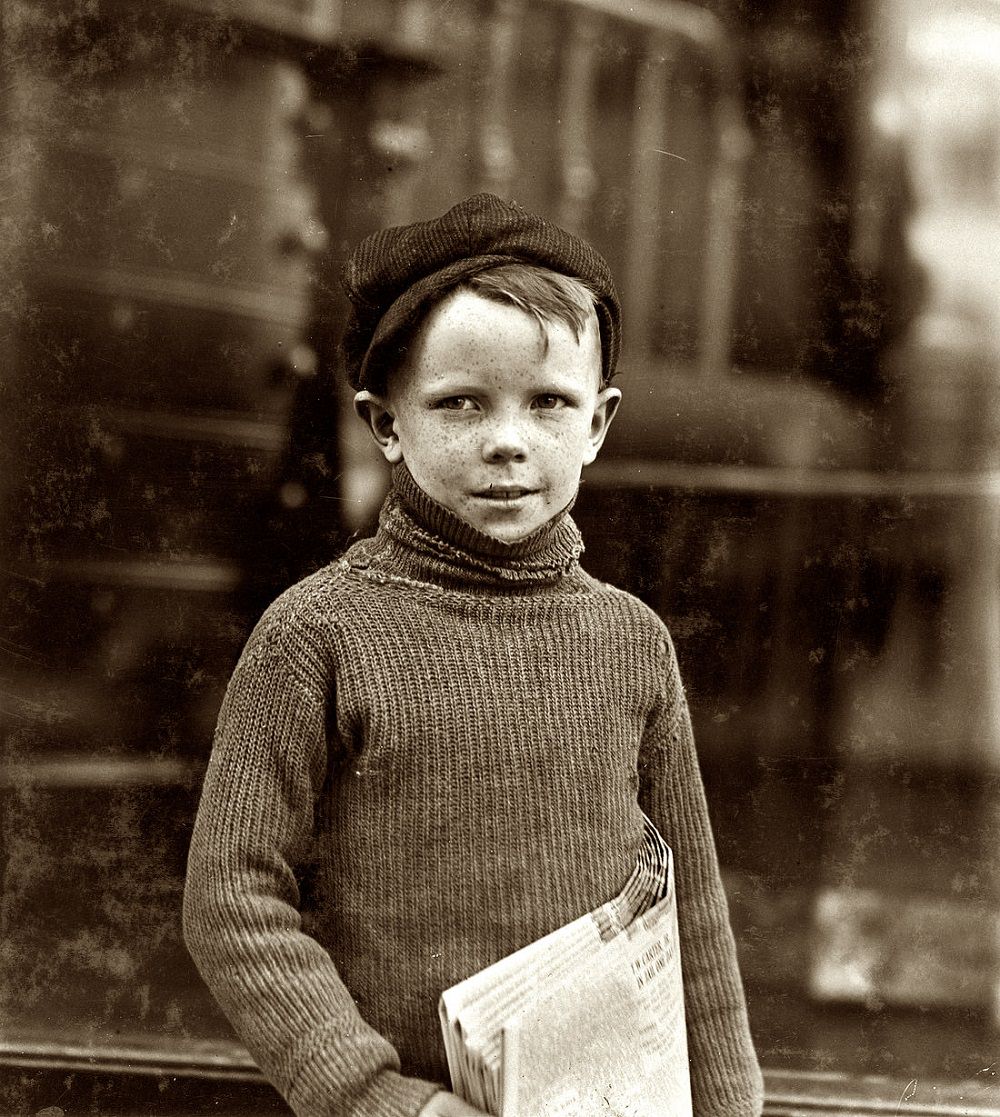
[369, 464, 583, 589]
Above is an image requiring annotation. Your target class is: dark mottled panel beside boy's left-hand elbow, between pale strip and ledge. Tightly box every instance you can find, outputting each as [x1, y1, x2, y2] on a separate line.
[0, 784, 203, 1044]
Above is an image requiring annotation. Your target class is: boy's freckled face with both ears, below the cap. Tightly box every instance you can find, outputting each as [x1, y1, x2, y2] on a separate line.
[355, 289, 621, 542]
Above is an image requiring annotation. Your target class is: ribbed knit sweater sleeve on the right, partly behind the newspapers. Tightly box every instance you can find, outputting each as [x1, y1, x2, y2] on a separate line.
[639, 633, 763, 1117]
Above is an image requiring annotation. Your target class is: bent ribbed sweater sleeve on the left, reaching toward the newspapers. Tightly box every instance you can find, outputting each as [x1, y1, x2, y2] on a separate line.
[183, 610, 439, 1117]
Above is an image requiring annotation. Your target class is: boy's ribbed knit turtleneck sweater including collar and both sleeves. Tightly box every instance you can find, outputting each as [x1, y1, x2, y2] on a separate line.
[184, 466, 761, 1117]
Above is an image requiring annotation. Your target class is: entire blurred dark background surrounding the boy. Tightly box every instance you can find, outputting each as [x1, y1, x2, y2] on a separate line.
[0, 0, 1000, 1117]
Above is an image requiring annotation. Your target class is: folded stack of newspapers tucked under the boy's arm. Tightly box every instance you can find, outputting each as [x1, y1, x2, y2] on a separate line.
[439, 820, 692, 1117]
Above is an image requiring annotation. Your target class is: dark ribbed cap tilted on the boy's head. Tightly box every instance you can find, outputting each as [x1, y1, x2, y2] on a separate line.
[343, 194, 621, 391]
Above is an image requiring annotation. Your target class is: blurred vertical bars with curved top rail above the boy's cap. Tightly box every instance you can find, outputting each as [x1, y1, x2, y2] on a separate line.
[471, 0, 750, 376]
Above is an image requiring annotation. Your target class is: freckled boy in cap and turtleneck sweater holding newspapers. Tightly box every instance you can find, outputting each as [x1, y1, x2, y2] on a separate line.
[184, 194, 761, 1117]
